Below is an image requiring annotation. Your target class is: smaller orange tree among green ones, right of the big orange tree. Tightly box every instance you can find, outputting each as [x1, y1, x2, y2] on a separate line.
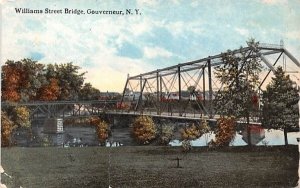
[39, 78, 60, 101]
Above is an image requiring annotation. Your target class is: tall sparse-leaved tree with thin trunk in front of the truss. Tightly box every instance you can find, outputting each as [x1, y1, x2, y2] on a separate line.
[214, 39, 262, 145]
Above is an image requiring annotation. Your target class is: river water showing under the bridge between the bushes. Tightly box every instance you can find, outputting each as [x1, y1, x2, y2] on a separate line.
[14, 125, 300, 147]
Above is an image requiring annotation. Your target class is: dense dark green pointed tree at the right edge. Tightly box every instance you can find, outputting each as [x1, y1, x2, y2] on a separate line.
[262, 67, 299, 145]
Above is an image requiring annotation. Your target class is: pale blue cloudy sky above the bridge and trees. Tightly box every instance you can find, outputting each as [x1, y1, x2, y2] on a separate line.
[0, 0, 300, 92]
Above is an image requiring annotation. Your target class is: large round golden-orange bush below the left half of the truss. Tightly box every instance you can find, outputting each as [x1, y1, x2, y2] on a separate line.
[132, 116, 156, 144]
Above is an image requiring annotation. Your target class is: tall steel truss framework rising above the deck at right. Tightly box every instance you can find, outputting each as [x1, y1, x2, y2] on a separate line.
[122, 44, 300, 118]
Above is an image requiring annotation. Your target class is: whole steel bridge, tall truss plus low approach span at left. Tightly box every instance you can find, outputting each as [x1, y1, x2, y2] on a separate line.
[1, 44, 300, 122]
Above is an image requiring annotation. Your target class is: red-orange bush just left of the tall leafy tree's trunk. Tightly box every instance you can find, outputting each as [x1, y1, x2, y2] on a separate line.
[216, 117, 236, 146]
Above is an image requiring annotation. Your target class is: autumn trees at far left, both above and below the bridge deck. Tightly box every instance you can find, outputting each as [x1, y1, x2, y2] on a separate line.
[1, 59, 105, 147]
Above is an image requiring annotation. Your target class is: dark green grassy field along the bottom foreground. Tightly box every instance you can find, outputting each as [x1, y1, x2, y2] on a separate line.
[1, 146, 299, 188]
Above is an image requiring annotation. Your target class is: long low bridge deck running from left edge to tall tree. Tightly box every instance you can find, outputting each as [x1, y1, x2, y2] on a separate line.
[1, 100, 260, 124]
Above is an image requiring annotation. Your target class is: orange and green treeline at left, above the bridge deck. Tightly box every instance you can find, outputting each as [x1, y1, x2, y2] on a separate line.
[1, 59, 100, 102]
